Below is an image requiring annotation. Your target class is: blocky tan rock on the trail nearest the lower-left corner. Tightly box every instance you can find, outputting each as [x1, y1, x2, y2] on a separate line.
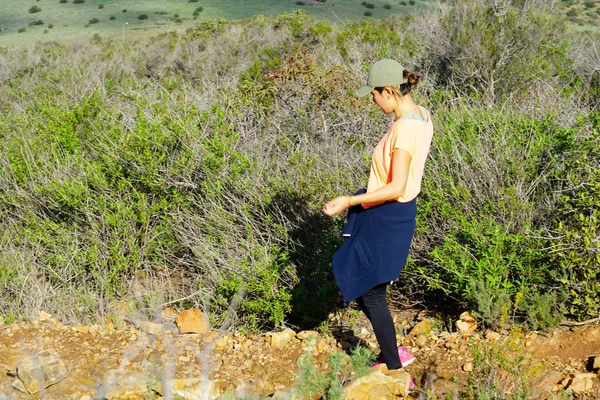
[16, 349, 69, 394]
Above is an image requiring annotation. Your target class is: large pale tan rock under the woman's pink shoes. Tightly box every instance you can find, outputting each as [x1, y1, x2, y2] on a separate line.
[342, 365, 410, 400]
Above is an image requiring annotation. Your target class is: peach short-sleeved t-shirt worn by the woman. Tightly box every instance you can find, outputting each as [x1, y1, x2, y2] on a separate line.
[363, 107, 433, 208]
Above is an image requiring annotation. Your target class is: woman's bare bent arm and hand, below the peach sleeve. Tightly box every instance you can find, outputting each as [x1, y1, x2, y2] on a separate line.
[323, 149, 412, 216]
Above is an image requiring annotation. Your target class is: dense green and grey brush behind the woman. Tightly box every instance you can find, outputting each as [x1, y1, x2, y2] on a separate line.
[0, 0, 600, 329]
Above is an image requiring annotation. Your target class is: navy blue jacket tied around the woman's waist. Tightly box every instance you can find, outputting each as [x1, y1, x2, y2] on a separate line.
[333, 189, 417, 302]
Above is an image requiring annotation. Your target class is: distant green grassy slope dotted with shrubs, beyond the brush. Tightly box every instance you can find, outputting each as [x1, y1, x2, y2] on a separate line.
[0, 0, 437, 45]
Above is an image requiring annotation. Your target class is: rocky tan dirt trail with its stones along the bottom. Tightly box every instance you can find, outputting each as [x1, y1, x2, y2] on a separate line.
[0, 308, 600, 400]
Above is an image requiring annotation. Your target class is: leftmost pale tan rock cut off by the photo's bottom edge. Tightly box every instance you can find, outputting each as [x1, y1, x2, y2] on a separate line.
[94, 369, 148, 400]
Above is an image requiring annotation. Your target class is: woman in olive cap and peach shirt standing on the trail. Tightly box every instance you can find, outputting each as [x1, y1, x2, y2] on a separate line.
[323, 59, 433, 376]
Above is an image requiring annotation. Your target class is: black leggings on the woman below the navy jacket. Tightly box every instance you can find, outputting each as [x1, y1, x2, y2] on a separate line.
[356, 283, 402, 369]
